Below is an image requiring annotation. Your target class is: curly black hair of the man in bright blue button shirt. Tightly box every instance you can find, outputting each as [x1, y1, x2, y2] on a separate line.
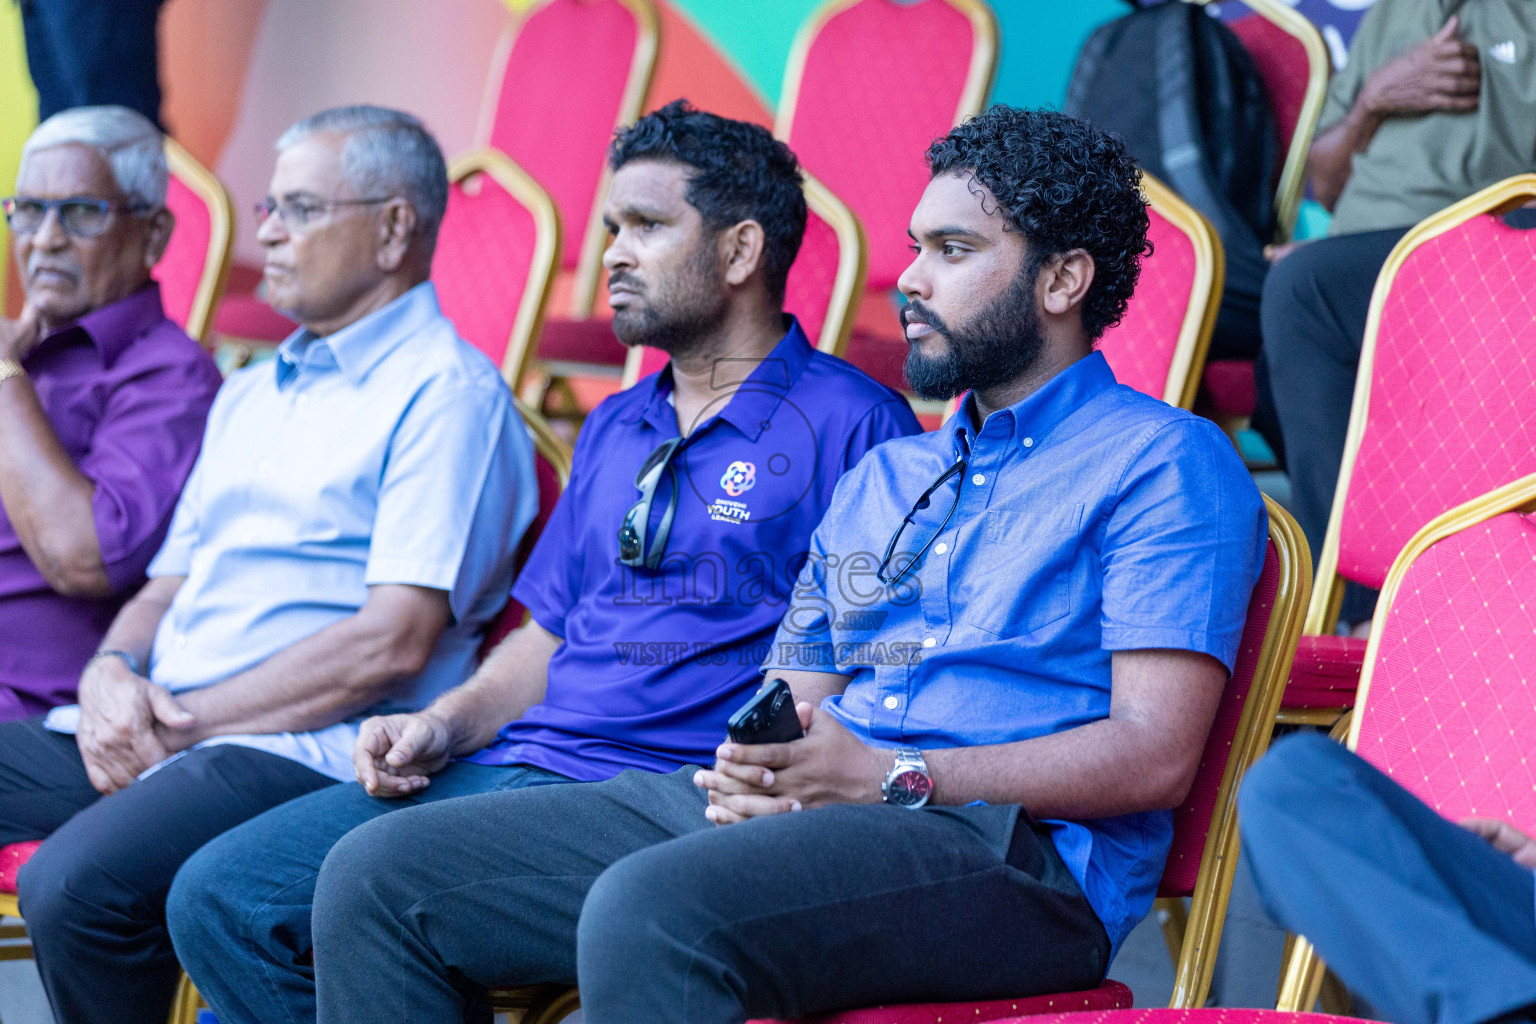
[928, 103, 1152, 339]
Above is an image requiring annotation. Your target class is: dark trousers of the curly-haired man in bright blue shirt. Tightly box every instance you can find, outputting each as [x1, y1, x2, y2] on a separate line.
[313, 769, 1109, 1024]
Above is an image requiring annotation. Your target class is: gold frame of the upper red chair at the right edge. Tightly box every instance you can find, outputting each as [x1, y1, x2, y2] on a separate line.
[1277, 170, 1536, 726]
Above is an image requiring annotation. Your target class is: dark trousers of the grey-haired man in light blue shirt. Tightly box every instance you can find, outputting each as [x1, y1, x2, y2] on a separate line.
[0, 718, 333, 1024]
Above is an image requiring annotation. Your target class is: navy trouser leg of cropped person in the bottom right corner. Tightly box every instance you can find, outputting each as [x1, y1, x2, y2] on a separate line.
[1240, 734, 1536, 1024]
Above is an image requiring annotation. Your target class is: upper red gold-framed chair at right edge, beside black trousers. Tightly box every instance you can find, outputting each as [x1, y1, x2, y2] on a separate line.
[1281, 175, 1536, 725]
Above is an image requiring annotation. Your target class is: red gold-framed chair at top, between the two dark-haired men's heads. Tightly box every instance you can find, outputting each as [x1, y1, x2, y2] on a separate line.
[774, 0, 997, 399]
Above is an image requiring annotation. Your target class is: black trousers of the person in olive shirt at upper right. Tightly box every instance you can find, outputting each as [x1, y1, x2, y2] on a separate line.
[1260, 227, 1407, 622]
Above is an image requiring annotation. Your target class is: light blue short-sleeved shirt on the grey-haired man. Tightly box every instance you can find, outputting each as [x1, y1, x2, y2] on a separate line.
[49, 282, 538, 780]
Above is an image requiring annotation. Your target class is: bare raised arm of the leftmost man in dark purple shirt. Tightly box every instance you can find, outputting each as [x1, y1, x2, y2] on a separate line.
[0, 306, 112, 597]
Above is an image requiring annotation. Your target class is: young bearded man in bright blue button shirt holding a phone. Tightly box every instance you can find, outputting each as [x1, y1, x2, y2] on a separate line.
[293, 106, 1266, 1024]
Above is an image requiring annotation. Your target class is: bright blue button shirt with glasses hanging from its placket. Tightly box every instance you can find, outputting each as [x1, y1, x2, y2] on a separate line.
[766, 352, 1267, 949]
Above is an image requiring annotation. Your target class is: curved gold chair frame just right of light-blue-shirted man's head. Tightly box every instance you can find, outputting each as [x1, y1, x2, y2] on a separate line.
[449, 149, 561, 395]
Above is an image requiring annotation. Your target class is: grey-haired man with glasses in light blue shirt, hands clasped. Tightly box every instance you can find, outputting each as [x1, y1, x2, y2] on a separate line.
[0, 107, 538, 1024]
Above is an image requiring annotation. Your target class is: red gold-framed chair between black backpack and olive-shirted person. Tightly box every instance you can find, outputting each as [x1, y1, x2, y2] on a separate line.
[1192, 0, 1332, 424]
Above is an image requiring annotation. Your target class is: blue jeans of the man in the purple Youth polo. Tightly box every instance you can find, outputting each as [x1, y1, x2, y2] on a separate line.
[166, 761, 571, 1024]
